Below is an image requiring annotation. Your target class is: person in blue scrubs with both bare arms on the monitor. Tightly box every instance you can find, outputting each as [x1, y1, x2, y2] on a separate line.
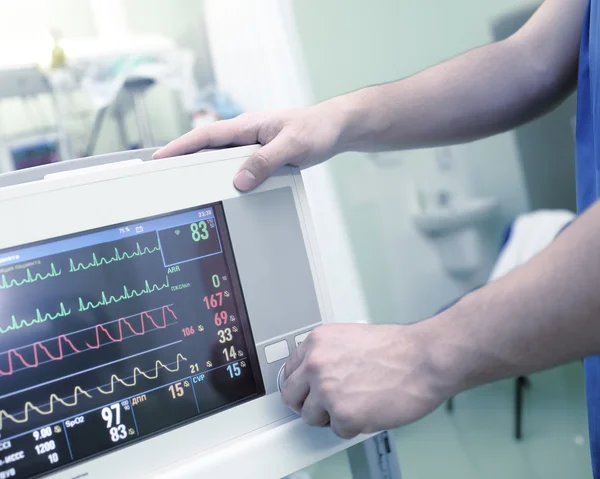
[155, 0, 600, 479]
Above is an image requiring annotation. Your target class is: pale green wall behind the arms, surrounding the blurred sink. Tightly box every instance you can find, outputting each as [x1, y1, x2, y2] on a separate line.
[294, 0, 528, 323]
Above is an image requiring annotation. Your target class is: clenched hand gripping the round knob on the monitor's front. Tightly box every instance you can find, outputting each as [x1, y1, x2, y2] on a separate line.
[282, 324, 450, 438]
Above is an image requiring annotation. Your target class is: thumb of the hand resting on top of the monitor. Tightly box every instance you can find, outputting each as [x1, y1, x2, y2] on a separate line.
[233, 133, 301, 191]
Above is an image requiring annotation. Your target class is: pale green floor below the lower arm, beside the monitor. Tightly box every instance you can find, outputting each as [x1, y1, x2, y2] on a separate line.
[310, 363, 592, 479]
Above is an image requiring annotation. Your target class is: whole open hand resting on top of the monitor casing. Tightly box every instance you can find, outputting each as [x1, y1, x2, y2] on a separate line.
[154, 103, 341, 191]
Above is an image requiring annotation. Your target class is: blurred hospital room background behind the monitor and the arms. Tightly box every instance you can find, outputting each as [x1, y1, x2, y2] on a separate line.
[0, 0, 591, 479]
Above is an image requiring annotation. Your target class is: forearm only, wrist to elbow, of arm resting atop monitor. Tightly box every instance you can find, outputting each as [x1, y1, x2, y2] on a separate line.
[332, 42, 570, 151]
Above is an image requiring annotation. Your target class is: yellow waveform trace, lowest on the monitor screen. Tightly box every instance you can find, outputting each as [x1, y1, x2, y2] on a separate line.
[0, 353, 187, 431]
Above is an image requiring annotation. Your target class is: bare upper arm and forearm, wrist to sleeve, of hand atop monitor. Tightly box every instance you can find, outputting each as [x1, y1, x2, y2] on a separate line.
[327, 0, 585, 151]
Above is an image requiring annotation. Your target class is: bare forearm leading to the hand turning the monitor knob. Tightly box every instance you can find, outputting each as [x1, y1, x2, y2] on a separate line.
[417, 199, 600, 394]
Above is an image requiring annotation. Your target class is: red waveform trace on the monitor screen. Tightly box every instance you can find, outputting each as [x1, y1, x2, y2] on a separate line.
[0, 306, 177, 376]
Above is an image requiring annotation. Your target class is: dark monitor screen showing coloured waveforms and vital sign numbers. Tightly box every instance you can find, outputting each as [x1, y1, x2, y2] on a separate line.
[0, 203, 264, 479]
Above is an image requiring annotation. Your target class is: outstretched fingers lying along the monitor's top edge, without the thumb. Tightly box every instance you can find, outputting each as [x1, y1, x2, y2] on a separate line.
[152, 117, 258, 159]
